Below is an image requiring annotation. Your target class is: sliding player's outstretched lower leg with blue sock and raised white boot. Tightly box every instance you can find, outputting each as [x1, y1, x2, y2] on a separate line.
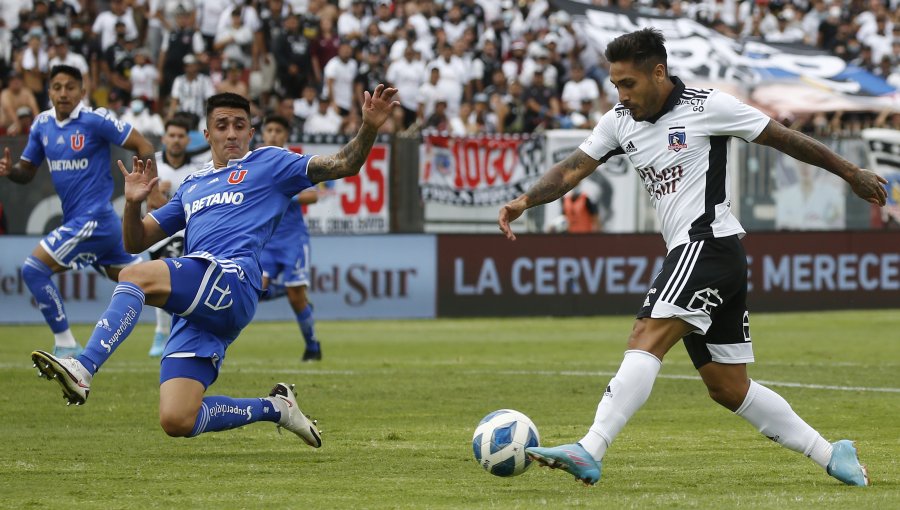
[31, 282, 144, 405]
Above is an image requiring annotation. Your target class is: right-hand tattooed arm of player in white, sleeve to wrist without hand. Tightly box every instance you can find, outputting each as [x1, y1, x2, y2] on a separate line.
[754, 121, 858, 181]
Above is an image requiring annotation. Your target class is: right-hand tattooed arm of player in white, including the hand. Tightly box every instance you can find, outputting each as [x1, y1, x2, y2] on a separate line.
[753, 120, 887, 206]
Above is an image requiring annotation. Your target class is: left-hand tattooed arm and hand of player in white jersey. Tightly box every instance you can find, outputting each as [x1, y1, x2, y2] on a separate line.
[497, 149, 600, 241]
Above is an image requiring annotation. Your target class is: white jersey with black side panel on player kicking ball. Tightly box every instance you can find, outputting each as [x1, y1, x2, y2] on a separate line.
[579, 77, 769, 250]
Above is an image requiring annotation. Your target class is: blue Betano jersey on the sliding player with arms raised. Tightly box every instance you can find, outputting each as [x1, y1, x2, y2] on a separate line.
[151, 147, 312, 288]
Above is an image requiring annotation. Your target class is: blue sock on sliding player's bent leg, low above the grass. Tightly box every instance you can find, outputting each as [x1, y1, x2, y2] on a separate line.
[188, 395, 281, 437]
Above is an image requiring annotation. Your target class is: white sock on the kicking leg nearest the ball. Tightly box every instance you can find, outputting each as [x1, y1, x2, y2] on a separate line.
[579, 350, 662, 462]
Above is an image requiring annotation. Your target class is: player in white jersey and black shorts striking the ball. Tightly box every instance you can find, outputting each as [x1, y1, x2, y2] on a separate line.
[498, 28, 886, 485]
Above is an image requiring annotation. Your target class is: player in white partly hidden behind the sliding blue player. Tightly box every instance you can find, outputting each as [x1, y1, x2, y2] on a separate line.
[147, 116, 200, 358]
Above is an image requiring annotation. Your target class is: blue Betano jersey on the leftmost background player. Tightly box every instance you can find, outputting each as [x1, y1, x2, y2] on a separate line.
[22, 104, 132, 222]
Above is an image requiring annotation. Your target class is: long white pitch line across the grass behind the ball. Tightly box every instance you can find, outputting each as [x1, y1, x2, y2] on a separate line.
[0, 363, 900, 393]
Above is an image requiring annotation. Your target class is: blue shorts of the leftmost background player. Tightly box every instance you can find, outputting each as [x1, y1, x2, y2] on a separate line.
[41, 208, 141, 274]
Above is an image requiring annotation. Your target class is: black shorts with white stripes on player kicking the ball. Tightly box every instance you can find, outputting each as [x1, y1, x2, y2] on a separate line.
[637, 235, 753, 368]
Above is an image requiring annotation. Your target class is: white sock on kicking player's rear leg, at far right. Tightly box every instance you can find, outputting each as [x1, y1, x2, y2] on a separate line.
[734, 380, 832, 468]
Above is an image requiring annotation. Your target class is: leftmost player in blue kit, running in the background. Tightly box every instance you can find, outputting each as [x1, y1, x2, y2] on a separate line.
[0, 65, 162, 357]
